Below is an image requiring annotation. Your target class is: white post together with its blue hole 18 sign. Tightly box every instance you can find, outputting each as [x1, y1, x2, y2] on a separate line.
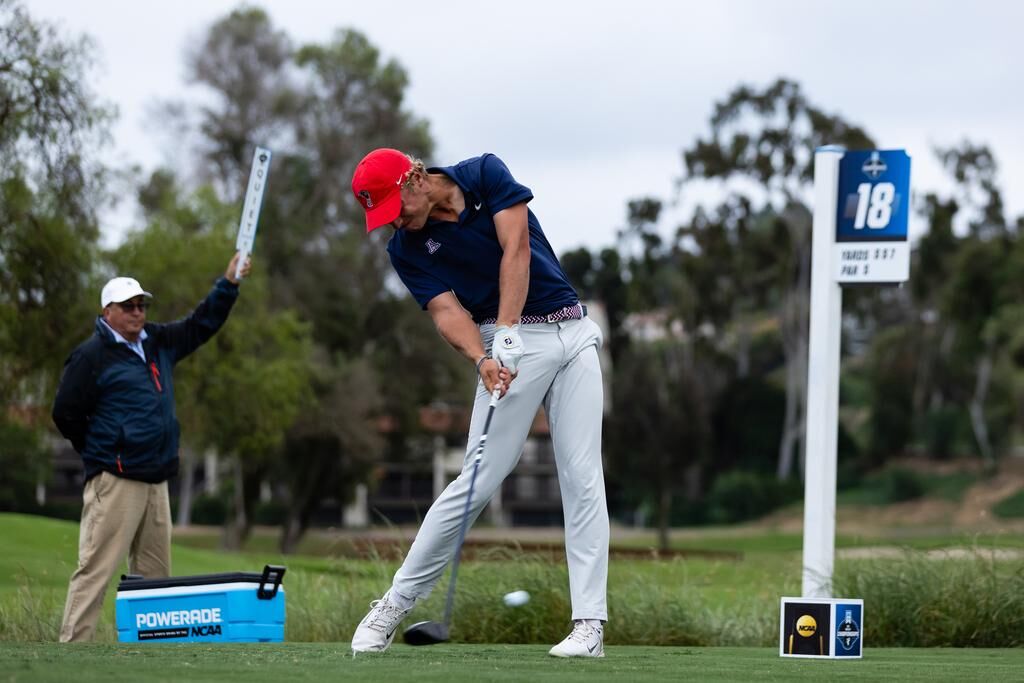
[803, 145, 910, 598]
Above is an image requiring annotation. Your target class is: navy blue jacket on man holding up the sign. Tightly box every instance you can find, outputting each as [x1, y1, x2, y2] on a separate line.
[53, 278, 239, 483]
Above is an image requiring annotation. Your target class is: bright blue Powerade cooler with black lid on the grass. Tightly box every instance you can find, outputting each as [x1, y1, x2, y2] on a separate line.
[116, 564, 285, 643]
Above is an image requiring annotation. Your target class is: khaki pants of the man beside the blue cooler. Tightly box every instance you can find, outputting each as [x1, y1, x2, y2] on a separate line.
[60, 472, 171, 643]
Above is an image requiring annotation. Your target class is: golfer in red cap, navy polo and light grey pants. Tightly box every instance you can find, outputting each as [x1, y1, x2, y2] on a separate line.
[352, 148, 608, 657]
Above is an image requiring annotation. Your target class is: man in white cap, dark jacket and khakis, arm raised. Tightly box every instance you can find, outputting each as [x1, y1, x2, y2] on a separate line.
[53, 254, 251, 642]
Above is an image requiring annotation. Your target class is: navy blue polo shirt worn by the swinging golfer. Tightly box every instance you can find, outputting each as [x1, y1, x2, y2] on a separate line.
[387, 154, 580, 322]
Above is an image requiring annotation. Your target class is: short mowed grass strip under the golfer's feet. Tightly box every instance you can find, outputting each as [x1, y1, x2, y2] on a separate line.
[0, 642, 1024, 683]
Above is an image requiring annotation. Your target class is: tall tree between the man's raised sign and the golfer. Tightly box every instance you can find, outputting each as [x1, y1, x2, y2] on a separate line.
[160, 9, 471, 548]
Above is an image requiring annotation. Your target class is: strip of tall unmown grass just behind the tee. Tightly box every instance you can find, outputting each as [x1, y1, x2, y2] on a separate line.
[6, 549, 1024, 647]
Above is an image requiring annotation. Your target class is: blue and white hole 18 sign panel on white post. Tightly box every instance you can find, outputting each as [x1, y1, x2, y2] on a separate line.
[833, 150, 910, 284]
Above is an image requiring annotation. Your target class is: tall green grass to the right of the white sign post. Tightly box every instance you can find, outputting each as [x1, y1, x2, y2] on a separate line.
[835, 548, 1024, 647]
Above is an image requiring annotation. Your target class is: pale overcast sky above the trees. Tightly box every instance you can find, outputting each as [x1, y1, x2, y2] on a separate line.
[27, 0, 1024, 253]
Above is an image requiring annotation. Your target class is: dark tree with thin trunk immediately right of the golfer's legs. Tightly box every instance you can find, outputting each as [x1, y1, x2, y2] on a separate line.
[609, 198, 732, 549]
